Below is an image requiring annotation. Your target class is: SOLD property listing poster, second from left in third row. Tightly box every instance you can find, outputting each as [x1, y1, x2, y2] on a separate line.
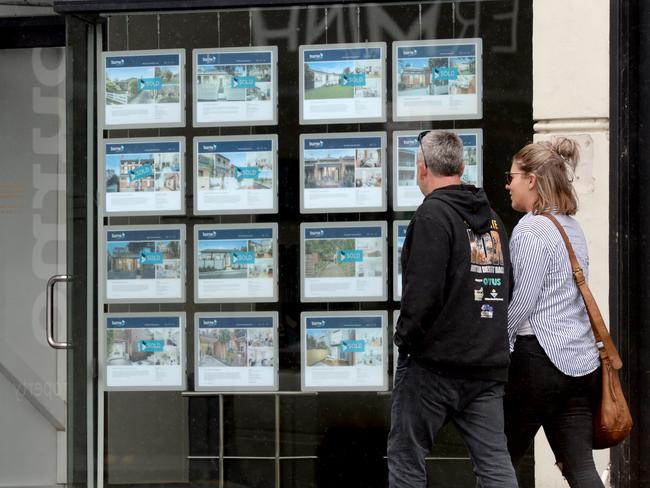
[194, 224, 278, 302]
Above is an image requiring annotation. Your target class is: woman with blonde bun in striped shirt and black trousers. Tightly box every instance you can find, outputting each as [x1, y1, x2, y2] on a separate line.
[505, 138, 603, 488]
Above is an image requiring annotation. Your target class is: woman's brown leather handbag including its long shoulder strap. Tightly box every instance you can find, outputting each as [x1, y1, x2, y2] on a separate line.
[542, 213, 632, 449]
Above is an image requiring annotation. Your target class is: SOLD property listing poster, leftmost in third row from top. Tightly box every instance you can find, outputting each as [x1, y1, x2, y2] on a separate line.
[104, 225, 185, 302]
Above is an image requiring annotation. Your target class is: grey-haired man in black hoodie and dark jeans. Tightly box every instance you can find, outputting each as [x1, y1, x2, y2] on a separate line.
[388, 131, 517, 488]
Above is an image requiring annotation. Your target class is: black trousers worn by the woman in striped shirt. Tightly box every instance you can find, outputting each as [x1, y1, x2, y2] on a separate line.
[504, 336, 604, 488]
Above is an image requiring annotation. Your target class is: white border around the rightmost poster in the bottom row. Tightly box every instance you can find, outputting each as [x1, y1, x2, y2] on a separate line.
[300, 310, 389, 392]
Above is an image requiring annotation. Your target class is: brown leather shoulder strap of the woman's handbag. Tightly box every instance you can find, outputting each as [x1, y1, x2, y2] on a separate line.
[540, 213, 623, 369]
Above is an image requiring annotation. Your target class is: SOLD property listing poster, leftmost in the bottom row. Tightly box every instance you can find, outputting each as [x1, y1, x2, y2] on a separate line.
[103, 313, 185, 390]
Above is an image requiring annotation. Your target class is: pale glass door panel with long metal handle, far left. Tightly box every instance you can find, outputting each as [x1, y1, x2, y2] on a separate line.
[0, 43, 69, 486]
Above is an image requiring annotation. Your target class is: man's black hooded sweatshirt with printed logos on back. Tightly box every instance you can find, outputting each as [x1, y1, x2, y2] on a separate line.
[395, 185, 510, 381]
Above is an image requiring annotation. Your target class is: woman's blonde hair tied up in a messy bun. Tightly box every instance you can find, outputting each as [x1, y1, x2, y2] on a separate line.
[512, 137, 580, 215]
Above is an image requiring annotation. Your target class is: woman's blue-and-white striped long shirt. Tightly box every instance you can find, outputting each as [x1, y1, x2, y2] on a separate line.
[508, 213, 600, 376]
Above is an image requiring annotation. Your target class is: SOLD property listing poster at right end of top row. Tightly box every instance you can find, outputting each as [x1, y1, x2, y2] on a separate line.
[393, 39, 483, 120]
